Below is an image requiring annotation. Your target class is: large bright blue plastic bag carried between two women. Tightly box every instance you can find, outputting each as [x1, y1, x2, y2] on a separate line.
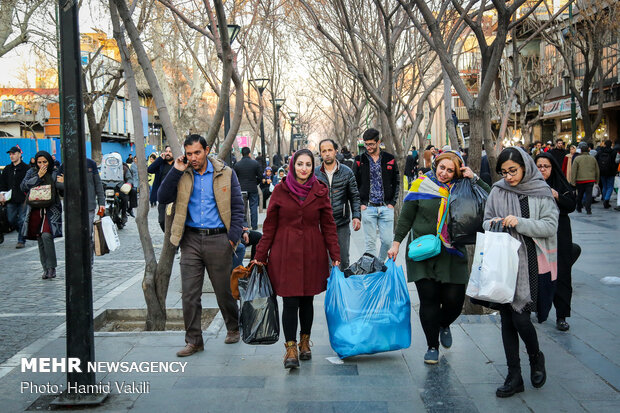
[325, 260, 411, 359]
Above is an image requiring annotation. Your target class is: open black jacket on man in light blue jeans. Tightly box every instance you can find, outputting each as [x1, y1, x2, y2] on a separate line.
[353, 151, 400, 206]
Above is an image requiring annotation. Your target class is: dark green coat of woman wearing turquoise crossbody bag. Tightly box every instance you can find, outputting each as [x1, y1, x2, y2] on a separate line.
[394, 179, 491, 284]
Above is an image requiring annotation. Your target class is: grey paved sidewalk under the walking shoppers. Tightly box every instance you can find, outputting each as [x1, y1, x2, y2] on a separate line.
[0, 203, 620, 413]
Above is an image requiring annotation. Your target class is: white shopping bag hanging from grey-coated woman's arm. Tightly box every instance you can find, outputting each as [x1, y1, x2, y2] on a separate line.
[466, 232, 521, 304]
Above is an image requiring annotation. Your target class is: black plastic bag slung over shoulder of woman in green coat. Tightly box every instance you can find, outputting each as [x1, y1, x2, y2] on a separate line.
[448, 179, 489, 245]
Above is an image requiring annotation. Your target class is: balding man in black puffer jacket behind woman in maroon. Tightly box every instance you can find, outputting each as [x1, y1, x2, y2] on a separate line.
[314, 139, 362, 271]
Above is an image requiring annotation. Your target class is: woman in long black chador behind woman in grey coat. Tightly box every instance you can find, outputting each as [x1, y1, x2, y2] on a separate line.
[534, 152, 579, 331]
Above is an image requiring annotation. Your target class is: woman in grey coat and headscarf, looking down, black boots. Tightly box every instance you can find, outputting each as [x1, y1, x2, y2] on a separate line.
[483, 148, 559, 397]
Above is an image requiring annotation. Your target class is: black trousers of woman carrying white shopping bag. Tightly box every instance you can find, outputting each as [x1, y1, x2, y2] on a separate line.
[499, 304, 539, 370]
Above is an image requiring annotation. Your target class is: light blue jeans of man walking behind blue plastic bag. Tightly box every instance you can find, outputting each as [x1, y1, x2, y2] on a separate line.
[362, 206, 394, 262]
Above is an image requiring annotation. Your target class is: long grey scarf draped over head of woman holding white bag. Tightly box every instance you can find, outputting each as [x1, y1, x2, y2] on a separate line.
[484, 148, 555, 312]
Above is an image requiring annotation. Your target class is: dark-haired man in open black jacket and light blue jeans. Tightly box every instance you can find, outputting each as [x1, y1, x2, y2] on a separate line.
[353, 128, 399, 262]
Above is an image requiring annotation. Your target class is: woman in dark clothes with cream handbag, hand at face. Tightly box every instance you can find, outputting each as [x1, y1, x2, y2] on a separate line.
[21, 151, 62, 280]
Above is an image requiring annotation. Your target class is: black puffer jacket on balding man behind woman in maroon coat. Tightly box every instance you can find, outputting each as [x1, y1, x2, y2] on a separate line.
[314, 163, 362, 227]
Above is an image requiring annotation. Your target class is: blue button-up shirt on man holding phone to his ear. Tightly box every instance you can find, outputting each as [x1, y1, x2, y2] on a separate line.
[185, 160, 224, 228]
